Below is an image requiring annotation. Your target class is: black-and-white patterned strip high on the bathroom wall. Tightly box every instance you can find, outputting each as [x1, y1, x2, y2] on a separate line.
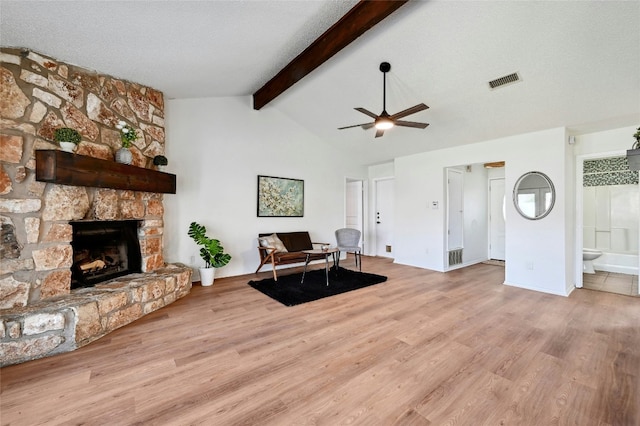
[582, 157, 638, 186]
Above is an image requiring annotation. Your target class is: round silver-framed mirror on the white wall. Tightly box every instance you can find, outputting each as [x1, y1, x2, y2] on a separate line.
[513, 172, 556, 220]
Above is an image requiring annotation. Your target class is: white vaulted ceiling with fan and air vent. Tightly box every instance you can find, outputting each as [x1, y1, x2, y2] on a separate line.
[0, 0, 640, 164]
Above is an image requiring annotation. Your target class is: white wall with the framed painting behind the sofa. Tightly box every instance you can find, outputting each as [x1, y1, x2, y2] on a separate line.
[164, 97, 367, 279]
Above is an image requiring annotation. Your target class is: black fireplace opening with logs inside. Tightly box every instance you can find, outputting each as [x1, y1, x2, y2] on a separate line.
[70, 220, 142, 289]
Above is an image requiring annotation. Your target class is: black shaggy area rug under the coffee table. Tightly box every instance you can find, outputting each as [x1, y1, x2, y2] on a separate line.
[249, 268, 387, 306]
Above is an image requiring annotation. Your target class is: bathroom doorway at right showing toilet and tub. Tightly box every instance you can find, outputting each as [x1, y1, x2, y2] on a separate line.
[576, 153, 640, 296]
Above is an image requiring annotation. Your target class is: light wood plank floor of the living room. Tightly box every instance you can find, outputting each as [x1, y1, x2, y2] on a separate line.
[0, 257, 640, 426]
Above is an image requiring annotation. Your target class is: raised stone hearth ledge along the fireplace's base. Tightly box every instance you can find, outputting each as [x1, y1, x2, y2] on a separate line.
[0, 265, 191, 367]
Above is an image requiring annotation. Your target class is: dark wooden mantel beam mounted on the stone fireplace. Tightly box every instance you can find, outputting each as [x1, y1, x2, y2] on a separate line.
[36, 150, 176, 194]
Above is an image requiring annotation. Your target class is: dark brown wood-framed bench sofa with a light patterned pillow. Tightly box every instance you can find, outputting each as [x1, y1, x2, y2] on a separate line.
[256, 231, 328, 281]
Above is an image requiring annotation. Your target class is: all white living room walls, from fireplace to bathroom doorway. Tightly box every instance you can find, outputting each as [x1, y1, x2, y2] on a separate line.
[165, 97, 635, 295]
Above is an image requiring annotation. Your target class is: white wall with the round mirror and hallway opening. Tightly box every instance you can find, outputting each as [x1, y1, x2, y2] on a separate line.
[394, 128, 574, 295]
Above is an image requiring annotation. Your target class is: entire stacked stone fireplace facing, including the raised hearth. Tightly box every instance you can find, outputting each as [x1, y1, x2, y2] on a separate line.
[0, 48, 191, 365]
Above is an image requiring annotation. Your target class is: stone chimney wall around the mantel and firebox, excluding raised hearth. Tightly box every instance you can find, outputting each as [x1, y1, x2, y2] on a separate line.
[0, 48, 165, 309]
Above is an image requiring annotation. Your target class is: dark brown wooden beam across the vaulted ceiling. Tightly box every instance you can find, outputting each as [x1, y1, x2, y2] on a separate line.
[253, 0, 409, 110]
